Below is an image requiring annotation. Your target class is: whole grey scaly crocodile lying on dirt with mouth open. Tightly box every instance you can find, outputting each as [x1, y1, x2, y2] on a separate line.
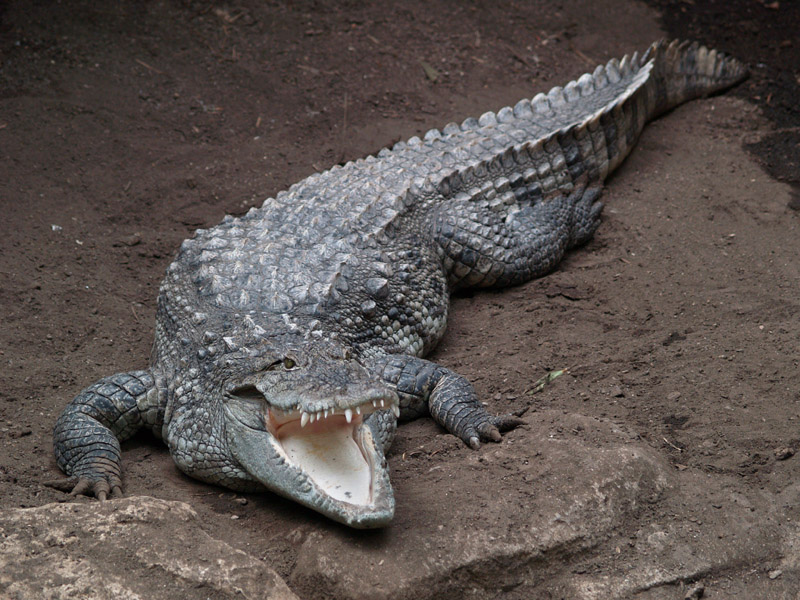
[50, 40, 747, 528]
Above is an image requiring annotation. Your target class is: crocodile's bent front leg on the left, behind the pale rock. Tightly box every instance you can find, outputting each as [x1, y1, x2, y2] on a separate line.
[46, 371, 163, 500]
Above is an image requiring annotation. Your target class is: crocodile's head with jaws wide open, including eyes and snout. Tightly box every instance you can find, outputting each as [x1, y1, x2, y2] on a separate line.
[223, 343, 399, 528]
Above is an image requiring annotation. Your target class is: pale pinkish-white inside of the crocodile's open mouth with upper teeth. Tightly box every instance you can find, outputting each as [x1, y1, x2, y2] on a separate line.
[266, 398, 400, 505]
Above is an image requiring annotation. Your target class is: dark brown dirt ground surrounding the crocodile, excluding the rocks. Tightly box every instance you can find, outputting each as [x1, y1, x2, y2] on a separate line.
[0, 0, 800, 598]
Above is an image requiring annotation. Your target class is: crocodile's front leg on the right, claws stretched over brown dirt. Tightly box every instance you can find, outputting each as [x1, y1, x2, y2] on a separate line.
[377, 354, 522, 450]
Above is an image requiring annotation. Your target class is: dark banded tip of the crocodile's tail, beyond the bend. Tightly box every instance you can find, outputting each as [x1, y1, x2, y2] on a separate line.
[642, 40, 747, 116]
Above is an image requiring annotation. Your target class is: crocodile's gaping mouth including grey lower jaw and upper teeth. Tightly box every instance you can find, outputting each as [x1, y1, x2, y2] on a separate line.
[223, 386, 400, 528]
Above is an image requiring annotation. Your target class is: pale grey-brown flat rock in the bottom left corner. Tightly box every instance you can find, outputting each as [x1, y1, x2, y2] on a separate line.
[0, 496, 297, 600]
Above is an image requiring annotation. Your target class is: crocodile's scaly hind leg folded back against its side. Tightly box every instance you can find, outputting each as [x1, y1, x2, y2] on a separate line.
[433, 182, 603, 288]
